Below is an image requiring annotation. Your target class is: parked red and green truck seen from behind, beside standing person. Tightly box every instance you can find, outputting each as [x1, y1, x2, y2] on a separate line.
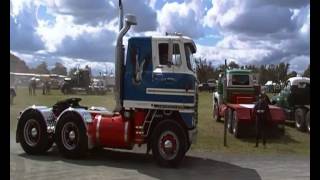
[213, 65, 285, 138]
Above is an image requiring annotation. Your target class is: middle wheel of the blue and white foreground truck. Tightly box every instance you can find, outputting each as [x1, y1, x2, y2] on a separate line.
[55, 114, 88, 159]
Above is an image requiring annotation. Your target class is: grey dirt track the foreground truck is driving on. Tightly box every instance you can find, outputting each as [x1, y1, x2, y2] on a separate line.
[10, 136, 310, 180]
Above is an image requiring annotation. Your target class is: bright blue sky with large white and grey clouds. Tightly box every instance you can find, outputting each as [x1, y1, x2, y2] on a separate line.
[10, 0, 310, 73]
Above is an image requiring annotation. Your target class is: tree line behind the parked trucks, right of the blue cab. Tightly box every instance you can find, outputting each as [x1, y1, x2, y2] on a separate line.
[195, 58, 310, 84]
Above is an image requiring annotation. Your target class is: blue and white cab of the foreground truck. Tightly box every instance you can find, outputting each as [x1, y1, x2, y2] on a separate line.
[123, 36, 197, 125]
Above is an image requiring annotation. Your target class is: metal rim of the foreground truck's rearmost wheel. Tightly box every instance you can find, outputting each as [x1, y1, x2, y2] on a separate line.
[23, 119, 41, 147]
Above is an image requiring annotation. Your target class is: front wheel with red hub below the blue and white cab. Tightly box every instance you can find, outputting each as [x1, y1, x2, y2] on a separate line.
[151, 120, 187, 167]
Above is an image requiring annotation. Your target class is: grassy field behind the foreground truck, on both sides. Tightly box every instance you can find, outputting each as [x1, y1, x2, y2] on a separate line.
[10, 88, 310, 155]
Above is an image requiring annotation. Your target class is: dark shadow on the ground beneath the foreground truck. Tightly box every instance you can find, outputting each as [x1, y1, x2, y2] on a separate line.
[19, 148, 261, 180]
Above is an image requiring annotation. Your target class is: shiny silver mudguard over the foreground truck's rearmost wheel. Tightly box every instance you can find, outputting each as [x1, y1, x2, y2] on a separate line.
[16, 105, 56, 142]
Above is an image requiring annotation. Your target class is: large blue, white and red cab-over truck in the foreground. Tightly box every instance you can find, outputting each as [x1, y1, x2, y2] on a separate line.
[16, 1, 198, 166]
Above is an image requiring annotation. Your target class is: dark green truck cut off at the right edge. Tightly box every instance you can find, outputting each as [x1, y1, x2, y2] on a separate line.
[271, 77, 310, 132]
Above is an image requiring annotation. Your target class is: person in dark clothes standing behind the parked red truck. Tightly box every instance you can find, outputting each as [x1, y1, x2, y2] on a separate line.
[253, 93, 271, 147]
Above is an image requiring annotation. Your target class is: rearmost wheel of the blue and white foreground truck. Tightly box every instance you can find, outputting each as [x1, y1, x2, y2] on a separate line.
[17, 112, 53, 155]
